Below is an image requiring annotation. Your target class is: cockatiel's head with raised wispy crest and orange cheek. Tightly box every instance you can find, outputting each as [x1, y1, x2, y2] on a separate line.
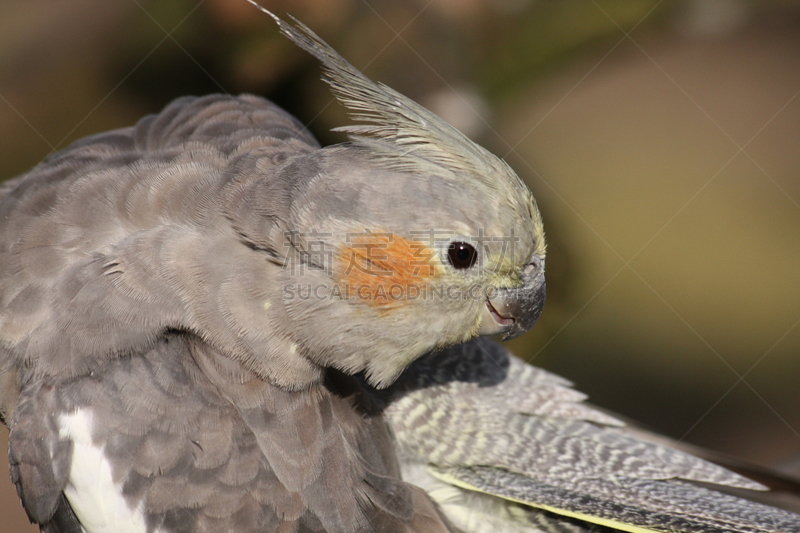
[238, 4, 545, 386]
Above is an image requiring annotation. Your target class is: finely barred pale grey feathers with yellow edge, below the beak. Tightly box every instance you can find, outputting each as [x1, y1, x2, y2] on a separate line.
[386, 339, 800, 532]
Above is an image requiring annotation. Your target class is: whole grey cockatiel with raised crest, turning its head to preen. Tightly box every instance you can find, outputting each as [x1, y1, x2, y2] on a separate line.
[0, 5, 800, 533]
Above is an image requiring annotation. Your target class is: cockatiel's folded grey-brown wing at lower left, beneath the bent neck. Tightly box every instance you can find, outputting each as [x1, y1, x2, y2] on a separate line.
[10, 335, 454, 533]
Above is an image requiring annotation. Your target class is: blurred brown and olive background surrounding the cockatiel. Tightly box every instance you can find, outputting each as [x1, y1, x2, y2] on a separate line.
[0, 0, 800, 532]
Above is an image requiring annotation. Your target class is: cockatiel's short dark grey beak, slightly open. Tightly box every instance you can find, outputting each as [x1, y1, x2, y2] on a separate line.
[478, 256, 546, 341]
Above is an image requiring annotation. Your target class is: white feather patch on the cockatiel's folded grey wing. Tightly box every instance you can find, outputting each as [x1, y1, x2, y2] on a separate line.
[58, 409, 153, 533]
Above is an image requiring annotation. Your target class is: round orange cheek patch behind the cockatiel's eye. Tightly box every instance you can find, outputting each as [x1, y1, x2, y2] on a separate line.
[337, 233, 438, 307]
